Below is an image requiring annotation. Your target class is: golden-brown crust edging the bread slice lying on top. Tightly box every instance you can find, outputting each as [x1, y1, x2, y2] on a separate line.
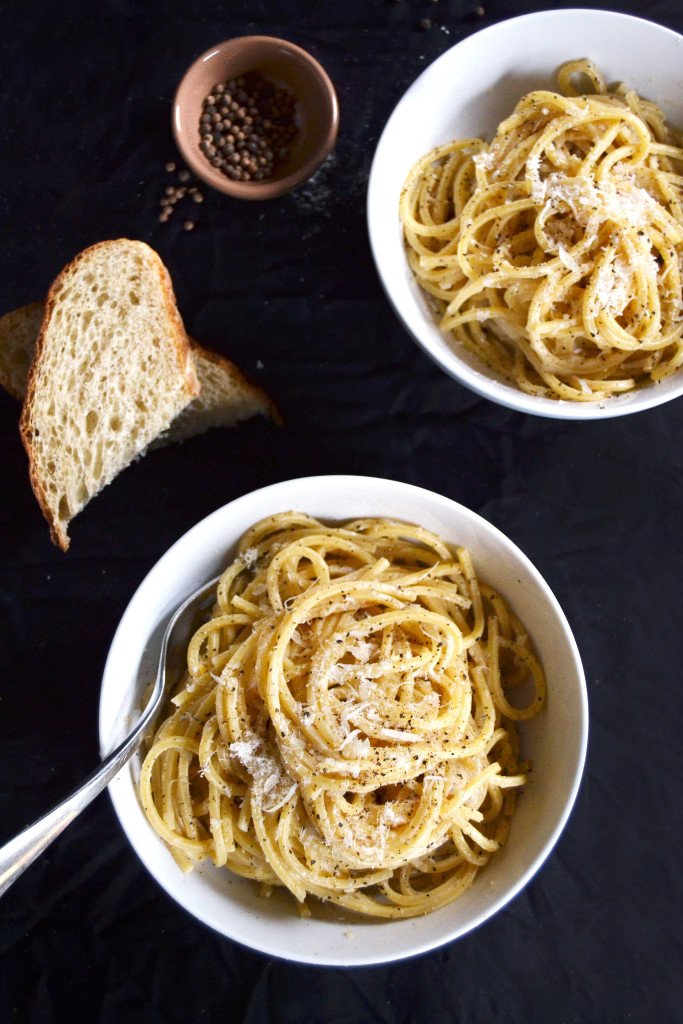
[19, 239, 200, 551]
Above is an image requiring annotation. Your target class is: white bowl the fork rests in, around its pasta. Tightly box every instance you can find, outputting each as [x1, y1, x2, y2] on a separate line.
[99, 476, 588, 966]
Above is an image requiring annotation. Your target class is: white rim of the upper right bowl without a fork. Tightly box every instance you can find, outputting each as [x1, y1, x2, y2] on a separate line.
[367, 7, 683, 421]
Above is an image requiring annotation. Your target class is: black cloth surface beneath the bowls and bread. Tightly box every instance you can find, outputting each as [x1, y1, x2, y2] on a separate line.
[0, 0, 683, 1024]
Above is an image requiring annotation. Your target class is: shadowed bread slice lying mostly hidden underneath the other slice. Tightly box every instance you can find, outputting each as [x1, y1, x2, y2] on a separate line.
[0, 302, 281, 447]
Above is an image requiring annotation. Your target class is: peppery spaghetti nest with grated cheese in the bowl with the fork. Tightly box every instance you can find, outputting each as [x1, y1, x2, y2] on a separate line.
[140, 512, 545, 918]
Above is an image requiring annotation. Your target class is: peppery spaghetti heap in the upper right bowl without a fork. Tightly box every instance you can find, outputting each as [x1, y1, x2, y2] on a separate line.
[399, 60, 683, 401]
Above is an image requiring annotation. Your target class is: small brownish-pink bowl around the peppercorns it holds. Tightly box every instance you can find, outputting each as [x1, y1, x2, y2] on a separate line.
[173, 36, 339, 200]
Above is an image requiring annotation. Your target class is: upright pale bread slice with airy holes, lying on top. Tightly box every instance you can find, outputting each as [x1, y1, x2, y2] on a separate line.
[19, 239, 200, 551]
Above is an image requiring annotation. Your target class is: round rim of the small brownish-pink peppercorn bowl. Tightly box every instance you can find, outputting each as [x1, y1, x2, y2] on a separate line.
[171, 35, 339, 200]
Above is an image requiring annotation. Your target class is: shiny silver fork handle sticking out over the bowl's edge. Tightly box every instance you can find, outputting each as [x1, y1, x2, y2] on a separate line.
[0, 722, 143, 896]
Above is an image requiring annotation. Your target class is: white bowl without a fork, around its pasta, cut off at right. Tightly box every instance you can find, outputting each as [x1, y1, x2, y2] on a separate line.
[368, 10, 683, 420]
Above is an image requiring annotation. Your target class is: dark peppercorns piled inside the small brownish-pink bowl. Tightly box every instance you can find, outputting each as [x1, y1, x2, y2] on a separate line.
[197, 71, 298, 184]
